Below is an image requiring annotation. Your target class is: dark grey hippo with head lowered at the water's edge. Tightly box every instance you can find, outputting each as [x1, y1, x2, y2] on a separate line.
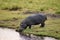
[18, 14, 47, 32]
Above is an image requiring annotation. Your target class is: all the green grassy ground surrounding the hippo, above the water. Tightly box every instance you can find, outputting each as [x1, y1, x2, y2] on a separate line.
[0, 0, 60, 39]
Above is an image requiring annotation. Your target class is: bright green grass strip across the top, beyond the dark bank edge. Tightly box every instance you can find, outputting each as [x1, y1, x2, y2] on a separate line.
[0, 0, 60, 13]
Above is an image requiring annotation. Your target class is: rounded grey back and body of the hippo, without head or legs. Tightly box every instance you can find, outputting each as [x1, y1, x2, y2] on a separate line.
[23, 14, 45, 25]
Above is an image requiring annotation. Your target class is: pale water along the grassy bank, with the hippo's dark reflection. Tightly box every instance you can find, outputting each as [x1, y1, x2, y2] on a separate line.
[0, 28, 57, 40]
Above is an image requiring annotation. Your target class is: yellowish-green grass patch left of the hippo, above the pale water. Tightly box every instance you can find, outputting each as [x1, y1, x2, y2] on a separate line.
[0, 10, 29, 28]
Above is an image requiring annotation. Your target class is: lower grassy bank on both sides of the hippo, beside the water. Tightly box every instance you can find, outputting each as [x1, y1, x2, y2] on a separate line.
[0, 11, 60, 38]
